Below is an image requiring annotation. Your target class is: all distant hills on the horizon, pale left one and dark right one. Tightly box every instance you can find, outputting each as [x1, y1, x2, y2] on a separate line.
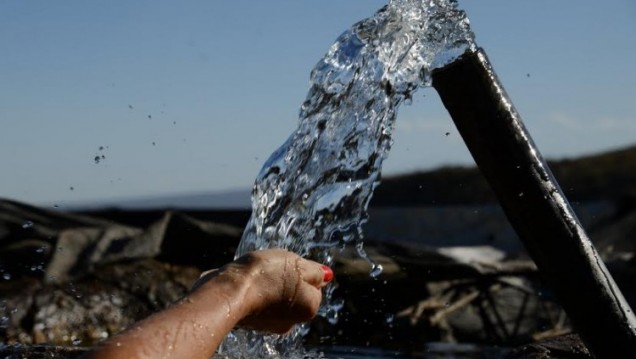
[71, 146, 636, 210]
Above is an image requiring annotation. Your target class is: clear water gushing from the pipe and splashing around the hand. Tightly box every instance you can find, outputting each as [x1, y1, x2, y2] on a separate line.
[220, 0, 474, 358]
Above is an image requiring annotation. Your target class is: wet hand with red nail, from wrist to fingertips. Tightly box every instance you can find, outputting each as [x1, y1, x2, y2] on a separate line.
[195, 249, 333, 334]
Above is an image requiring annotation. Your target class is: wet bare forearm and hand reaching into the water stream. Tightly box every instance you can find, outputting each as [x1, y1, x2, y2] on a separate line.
[82, 249, 333, 359]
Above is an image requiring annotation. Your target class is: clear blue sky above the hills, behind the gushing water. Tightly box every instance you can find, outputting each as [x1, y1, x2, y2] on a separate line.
[0, 0, 636, 203]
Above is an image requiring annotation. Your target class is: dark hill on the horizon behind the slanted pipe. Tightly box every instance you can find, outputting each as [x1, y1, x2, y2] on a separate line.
[371, 146, 636, 206]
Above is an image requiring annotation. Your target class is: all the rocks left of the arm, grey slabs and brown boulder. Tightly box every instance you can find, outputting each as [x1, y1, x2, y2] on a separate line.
[0, 201, 241, 352]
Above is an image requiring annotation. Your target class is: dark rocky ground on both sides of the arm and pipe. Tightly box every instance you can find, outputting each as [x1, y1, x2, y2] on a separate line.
[0, 201, 636, 358]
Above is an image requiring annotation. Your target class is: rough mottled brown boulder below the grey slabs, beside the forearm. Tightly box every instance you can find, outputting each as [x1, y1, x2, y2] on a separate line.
[0, 259, 199, 346]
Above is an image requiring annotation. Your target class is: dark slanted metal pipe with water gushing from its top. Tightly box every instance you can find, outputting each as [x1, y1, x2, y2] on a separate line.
[433, 49, 636, 358]
